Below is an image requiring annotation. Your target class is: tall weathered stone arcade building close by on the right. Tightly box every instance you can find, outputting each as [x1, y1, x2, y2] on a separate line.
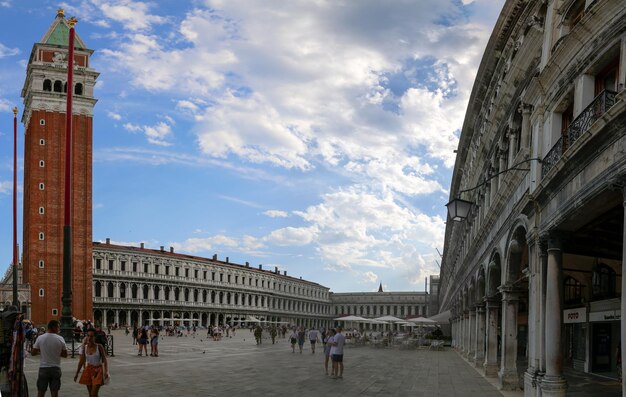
[439, 0, 626, 396]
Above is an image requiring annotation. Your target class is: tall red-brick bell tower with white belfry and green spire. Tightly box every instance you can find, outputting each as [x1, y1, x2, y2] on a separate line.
[22, 9, 99, 324]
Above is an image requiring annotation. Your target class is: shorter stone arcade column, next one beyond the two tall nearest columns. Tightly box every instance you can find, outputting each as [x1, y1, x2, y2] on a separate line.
[498, 286, 519, 390]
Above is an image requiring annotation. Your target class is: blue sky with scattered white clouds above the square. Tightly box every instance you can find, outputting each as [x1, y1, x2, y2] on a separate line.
[0, 0, 503, 292]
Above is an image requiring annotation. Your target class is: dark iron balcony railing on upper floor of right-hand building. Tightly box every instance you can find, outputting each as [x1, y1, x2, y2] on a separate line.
[541, 90, 616, 178]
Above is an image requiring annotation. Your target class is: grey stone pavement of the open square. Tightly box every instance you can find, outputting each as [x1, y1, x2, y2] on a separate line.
[25, 330, 502, 397]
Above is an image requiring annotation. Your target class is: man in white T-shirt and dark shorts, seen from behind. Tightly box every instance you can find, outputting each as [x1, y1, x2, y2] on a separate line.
[31, 320, 67, 397]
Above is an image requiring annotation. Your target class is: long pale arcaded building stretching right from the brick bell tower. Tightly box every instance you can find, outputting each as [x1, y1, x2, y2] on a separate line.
[93, 240, 331, 327]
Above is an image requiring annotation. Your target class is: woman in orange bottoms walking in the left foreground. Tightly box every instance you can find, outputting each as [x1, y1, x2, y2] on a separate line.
[74, 328, 109, 397]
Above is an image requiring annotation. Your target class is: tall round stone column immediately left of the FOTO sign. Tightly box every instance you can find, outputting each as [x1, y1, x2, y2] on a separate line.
[541, 235, 567, 397]
